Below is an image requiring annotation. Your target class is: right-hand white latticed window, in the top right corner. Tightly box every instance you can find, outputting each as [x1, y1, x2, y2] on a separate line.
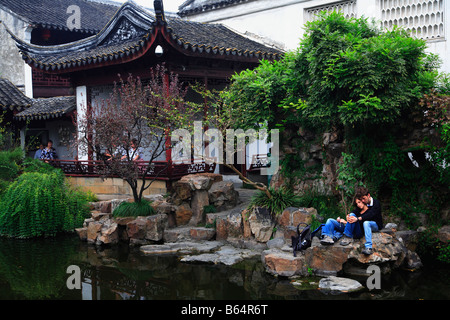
[380, 0, 444, 39]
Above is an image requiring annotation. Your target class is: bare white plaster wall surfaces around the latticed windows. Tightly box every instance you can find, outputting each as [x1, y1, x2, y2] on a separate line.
[185, 0, 450, 72]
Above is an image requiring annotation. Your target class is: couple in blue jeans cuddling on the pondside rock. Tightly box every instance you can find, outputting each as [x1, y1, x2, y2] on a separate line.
[321, 187, 383, 255]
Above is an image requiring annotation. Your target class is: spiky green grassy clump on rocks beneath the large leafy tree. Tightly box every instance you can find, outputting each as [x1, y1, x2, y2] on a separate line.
[249, 188, 300, 216]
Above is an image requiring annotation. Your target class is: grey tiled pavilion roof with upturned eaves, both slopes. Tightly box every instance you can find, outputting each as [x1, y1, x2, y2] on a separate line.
[9, 0, 283, 72]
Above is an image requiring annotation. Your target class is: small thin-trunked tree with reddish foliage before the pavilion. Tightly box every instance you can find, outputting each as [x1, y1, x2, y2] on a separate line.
[75, 65, 202, 202]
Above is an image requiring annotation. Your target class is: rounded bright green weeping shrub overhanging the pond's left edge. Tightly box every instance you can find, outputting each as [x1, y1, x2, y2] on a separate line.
[0, 171, 89, 238]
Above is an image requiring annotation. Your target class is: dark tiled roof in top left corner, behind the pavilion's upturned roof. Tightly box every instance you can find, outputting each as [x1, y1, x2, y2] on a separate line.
[0, 0, 120, 34]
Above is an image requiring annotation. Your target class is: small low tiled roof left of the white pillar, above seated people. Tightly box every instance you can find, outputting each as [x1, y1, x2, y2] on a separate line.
[15, 96, 76, 120]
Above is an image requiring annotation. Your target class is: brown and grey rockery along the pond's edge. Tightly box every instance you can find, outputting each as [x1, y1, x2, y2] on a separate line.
[72, 174, 450, 294]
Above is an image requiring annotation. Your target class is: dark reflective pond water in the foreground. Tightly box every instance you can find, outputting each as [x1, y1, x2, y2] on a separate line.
[0, 235, 450, 300]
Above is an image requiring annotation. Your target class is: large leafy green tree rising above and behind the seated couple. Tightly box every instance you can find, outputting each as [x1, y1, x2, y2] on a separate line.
[223, 12, 450, 225]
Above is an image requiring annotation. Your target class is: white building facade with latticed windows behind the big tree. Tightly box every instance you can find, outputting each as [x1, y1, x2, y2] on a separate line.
[178, 0, 450, 72]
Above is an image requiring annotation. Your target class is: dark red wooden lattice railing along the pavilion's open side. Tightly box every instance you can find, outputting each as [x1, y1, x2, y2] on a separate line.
[47, 160, 216, 180]
